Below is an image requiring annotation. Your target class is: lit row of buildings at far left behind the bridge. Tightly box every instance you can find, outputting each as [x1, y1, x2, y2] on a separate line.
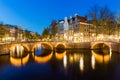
[0, 24, 35, 41]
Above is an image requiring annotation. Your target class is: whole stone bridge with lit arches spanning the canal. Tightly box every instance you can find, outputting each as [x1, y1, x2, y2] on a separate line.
[0, 41, 119, 53]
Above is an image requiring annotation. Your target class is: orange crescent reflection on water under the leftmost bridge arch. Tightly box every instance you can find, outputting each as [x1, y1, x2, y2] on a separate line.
[10, 54, 29, 67]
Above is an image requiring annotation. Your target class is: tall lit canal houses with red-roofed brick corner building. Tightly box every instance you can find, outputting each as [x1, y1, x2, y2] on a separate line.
[57, 14, 96, 42]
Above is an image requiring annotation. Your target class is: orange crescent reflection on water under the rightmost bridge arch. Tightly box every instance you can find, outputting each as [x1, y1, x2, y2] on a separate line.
[92, 50, 112, 63]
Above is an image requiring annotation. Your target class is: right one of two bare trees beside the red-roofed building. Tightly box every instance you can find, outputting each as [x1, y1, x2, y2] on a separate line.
[99, 6, 115, 35]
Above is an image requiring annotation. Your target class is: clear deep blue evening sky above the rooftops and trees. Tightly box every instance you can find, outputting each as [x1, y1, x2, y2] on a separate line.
[0, 0, 120, 34]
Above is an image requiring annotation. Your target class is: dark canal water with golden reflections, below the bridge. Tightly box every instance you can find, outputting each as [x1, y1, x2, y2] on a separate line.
[0, 46, 120, 80]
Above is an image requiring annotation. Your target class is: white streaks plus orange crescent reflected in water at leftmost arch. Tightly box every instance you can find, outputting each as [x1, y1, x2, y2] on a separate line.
[10, 45, 29, 67]
